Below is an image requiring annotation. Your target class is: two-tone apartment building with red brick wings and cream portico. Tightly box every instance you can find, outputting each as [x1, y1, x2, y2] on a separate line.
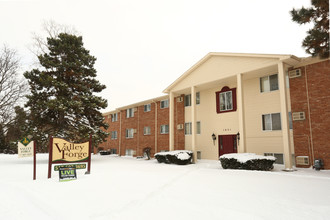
[102, 53, 330, 170]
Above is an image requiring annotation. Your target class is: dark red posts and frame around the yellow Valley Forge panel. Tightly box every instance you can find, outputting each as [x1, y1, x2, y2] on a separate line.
[48, 135, 92, 179]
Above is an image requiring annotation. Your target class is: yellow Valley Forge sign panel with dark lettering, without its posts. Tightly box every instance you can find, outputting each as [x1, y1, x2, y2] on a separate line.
[52, 138, 89, 162]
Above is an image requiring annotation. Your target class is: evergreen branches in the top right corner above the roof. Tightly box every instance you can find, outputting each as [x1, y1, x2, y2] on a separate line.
[290, 0, 329, 58]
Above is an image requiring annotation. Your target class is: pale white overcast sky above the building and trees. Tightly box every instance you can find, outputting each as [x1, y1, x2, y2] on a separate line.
[0, 0, 310, 112]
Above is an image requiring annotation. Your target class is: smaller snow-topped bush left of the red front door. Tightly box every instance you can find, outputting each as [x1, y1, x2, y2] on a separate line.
[155, 150, 192, 165]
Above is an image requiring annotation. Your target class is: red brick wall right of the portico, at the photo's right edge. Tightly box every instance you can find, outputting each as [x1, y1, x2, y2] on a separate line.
[290, 60, 330, 169]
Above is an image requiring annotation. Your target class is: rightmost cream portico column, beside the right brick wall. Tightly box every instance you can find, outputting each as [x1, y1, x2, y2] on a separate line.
[278, 61, 292, 170]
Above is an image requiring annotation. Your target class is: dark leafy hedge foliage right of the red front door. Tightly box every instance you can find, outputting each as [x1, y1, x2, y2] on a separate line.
[220, 156, 275, 171]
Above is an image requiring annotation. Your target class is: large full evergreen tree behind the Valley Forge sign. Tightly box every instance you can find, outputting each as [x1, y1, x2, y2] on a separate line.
[24, 33, 108, 147]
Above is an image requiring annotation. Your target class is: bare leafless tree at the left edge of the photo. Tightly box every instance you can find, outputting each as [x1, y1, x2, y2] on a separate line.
[0, 46, 28, 132]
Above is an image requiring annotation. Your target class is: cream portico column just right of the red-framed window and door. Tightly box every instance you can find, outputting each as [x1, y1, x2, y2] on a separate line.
[237, 73, 246, 153]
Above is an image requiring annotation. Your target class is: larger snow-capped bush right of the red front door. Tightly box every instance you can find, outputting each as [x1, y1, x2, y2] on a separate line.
[219, 153, 276, 171]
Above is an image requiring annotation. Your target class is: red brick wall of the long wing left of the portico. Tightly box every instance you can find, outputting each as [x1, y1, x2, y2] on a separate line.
[95, 97, 185, 156]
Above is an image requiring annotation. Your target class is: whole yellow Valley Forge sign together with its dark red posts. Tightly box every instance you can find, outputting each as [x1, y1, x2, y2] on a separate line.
[48, 136, 92, 178]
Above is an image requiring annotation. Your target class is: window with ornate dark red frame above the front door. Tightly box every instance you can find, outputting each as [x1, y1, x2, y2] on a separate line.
[215, 86, 237, 113]
